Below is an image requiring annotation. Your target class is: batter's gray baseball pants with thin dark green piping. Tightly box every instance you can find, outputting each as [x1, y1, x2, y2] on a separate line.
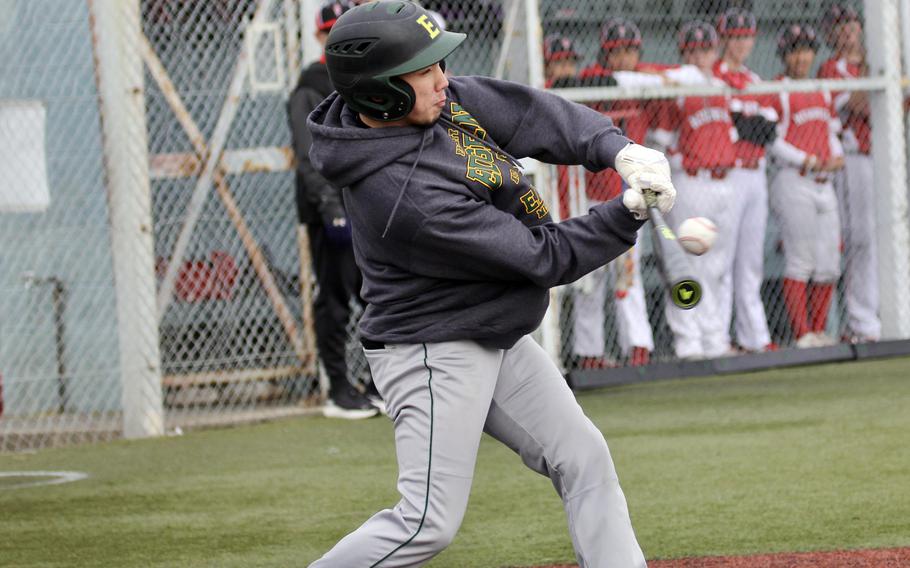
[310, 336, 646, 568]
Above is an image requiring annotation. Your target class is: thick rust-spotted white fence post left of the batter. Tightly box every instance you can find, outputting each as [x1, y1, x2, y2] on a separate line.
[89, 0, 164, 438]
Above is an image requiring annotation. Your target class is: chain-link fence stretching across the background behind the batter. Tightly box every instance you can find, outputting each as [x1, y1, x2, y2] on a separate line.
[0, 0, 910, 450]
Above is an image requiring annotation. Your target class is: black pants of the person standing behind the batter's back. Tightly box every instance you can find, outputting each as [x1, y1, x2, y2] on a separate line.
[307, 224, 363, 396]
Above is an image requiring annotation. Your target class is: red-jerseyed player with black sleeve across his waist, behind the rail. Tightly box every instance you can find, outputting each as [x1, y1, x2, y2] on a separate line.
[714, 8, 777, 351]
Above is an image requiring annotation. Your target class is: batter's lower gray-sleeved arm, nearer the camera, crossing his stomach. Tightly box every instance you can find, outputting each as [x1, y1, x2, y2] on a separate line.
[407, 197, 642, 288]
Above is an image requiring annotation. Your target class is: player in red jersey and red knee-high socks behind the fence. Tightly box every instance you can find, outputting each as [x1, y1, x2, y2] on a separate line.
[771, 25, 844, 347]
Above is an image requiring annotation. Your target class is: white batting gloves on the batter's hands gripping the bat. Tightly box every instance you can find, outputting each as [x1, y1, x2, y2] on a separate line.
[616, 144, 676, 219]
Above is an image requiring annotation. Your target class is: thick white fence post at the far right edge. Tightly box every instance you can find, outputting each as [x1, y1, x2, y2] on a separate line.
[865, 0, 910, 339]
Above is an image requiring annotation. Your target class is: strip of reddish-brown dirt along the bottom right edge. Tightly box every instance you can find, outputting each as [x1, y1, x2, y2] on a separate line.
[538, 548, 910, 568]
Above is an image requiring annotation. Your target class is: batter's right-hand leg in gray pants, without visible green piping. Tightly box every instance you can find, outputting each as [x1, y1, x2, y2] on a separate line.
[486, 336, 645, 568]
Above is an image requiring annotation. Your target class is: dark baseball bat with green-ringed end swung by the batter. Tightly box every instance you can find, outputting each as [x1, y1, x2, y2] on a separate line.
[644, 189, 701, 310]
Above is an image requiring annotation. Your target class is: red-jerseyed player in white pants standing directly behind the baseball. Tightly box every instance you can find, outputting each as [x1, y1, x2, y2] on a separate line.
[655, 20, 737, 359]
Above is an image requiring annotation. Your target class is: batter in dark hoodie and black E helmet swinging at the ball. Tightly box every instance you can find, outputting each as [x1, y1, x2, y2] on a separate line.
[308, 0, 675, 568]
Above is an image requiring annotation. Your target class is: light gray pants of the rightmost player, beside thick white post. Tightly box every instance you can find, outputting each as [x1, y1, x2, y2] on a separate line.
[841, 154, 881, 339]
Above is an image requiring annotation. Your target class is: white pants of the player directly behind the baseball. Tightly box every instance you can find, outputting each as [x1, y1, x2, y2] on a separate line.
[665, 172, 736, 359]
